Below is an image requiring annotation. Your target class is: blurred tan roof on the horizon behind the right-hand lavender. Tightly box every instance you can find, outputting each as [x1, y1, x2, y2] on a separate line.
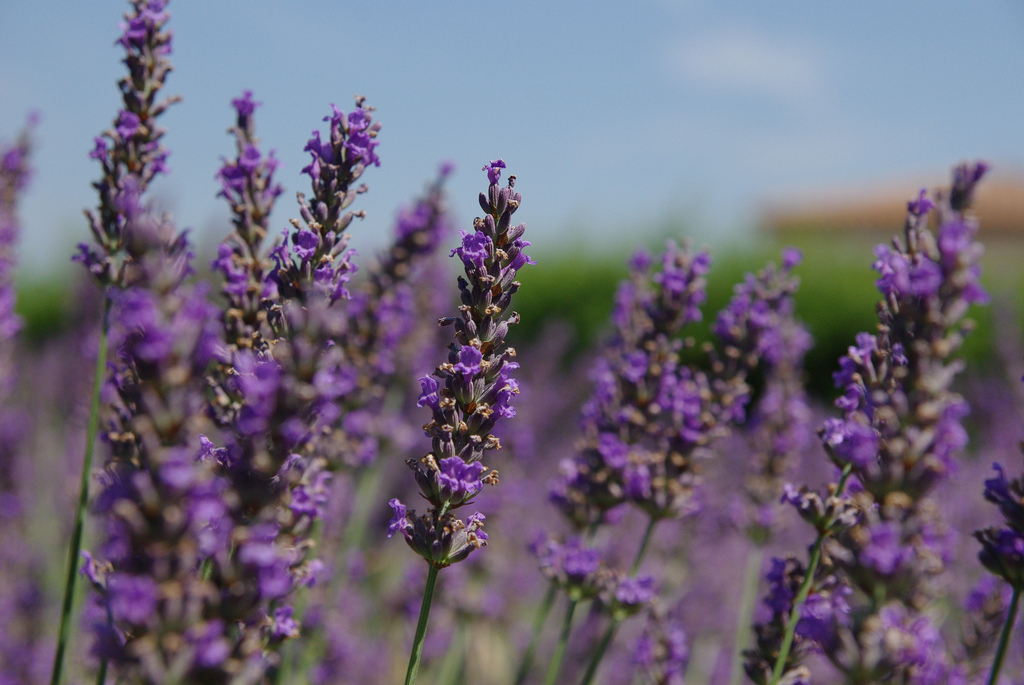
[758, 166, 1024, 239]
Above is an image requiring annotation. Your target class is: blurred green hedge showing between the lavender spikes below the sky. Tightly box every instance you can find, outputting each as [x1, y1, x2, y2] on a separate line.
[9, 235, 1007, 397]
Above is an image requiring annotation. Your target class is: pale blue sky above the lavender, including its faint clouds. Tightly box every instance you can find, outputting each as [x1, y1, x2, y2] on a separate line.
[0, 0, 1024, 265]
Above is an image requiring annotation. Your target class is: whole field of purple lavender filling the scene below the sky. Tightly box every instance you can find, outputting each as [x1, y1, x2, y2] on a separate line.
[6, 0, 1024, 685]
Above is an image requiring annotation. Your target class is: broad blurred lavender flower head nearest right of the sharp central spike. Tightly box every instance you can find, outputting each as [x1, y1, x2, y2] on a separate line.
[551, 243, 711, 527]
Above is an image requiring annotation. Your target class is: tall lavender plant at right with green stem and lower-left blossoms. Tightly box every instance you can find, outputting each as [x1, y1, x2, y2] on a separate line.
[746, 164, 987, 683]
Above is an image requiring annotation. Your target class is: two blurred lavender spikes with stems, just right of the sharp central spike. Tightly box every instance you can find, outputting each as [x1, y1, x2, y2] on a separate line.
[519, 243, 802, 683]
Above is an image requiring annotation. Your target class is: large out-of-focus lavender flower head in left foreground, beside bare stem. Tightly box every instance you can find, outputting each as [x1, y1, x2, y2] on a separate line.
[86, 254, 278, 683]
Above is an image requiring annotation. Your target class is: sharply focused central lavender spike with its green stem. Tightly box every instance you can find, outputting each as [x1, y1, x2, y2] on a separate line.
[388, 160, 534, 685]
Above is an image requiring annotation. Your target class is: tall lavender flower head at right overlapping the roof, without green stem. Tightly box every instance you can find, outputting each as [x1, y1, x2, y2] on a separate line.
[822, 167, 986, 679]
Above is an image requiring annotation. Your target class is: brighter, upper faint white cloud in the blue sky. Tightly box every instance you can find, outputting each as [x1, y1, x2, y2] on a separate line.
[671, 28, 825, 104]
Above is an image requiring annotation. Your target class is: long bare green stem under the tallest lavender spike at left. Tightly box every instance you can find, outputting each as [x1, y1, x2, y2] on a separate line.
[50, 298, 111, 685]
